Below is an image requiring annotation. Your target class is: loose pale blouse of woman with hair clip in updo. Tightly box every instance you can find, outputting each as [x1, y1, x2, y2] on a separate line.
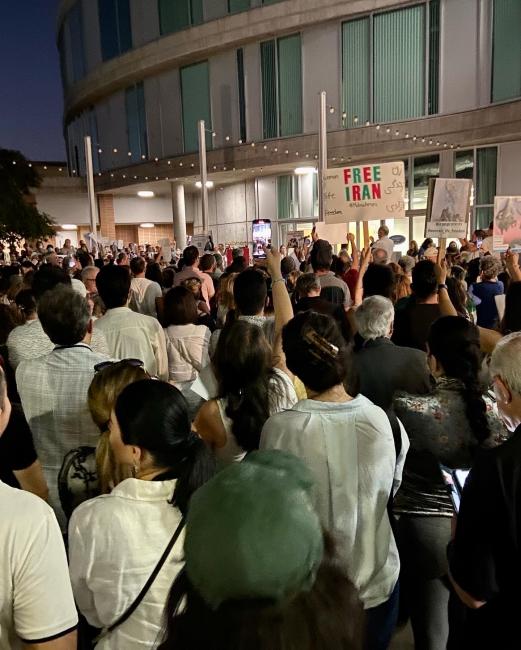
[260, 395, 409, 609]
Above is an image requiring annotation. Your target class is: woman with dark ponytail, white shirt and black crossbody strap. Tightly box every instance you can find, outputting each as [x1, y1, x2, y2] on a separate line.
[69, 379, 212, 650]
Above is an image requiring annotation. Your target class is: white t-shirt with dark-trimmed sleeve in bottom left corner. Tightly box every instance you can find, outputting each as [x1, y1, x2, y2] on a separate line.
[0, 481, 78, 650]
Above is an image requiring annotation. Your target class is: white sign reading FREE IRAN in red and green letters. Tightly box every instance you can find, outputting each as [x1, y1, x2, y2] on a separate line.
[323, 162, 405, 223]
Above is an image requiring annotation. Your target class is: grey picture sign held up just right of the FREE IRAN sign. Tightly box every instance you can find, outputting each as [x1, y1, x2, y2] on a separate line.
[425, 178, 472, 239]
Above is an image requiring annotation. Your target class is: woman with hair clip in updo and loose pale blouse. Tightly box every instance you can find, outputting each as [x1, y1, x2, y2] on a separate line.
[261, 311, 409, 650]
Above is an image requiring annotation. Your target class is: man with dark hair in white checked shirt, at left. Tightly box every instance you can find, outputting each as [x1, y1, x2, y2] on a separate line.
[16, 287, 107, 526]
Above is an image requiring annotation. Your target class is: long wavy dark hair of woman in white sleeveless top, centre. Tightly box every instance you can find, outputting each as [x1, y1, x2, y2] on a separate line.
[213, 315, 284, 451]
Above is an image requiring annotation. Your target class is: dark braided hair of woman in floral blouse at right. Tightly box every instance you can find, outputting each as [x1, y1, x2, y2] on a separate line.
[428, 316, 490, 443]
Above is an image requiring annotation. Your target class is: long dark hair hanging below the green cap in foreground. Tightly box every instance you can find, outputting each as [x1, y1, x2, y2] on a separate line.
[159, 535, 364, 650]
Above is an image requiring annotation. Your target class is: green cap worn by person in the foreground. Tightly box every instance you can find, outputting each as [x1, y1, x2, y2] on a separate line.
[184, 451, 324, 609]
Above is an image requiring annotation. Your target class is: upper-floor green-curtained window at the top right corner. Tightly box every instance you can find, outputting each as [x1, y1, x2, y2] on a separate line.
[492, 0, 521, 102]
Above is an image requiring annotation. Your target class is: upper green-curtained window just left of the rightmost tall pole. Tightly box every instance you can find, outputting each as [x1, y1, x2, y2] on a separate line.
[261, 34, 302, 138]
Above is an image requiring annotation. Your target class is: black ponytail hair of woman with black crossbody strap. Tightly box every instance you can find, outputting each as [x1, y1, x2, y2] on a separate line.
[115, 379, 214, 514]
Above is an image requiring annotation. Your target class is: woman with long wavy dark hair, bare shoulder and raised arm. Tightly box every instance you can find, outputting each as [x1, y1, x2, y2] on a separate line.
[195, 250, 297, 466]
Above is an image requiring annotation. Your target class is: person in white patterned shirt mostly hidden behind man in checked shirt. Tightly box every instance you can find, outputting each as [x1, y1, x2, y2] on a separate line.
[7, 264, 109, 370]
